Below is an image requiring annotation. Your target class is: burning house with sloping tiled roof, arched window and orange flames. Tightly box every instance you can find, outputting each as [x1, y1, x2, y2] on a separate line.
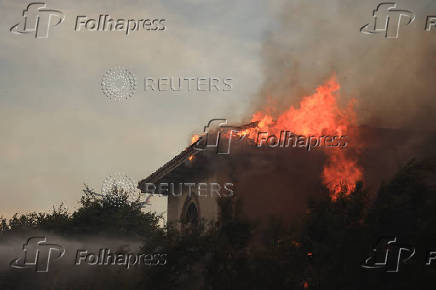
[138, 78, 434, 229]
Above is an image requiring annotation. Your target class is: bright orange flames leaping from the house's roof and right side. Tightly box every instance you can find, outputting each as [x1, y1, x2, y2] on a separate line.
[245, 76, 363, 201]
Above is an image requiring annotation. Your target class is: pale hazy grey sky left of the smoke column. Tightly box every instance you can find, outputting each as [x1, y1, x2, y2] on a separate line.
[0, 0, 273, 216]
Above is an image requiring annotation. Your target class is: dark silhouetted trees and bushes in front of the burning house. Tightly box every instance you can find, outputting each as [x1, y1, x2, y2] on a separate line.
[0, 160, 436, 290]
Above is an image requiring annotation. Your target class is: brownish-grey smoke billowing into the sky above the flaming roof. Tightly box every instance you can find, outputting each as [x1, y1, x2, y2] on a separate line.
[252, 0, 436, 129]
